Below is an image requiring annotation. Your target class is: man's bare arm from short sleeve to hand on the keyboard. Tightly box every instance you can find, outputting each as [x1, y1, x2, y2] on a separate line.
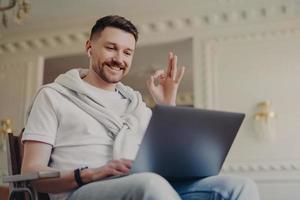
[21, 142, 131, 193]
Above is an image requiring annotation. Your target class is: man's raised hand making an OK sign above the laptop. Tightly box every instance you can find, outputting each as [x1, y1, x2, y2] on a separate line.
[147, 52, 185, 105]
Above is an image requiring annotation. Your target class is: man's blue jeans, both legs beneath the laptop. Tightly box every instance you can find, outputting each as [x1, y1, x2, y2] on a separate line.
[68, 173, 259, 200]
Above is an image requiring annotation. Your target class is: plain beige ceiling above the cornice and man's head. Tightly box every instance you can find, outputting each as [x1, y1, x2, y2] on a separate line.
[0, 0, 284, 39]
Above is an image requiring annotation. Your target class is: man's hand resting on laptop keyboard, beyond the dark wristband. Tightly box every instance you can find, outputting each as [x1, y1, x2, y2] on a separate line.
[81, 159, 132, 183]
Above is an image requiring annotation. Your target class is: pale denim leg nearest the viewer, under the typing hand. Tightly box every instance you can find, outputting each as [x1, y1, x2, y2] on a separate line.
[68, 173, 180, 200]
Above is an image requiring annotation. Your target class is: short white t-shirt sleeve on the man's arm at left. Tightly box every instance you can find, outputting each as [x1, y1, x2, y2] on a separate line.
[22, 88, 58, 146]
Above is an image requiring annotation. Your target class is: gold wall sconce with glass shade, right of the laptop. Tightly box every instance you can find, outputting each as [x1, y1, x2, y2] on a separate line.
[254, 101, 276, 140]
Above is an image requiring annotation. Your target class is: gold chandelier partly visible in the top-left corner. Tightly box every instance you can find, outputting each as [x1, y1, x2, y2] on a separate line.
[0, 0, 30, 28]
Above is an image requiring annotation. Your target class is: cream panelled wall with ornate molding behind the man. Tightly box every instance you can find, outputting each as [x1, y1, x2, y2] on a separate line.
[0, 0, 300, 200]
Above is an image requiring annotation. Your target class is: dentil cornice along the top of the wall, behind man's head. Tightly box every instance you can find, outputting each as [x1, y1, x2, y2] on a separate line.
[0, 0, 300, 56]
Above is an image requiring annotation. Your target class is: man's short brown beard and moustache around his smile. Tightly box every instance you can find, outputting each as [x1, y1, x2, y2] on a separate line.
[92, 60, 126, 84]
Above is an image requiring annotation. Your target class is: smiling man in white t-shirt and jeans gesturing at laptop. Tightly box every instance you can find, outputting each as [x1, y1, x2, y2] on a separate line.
[22, 16, 258, 200]
